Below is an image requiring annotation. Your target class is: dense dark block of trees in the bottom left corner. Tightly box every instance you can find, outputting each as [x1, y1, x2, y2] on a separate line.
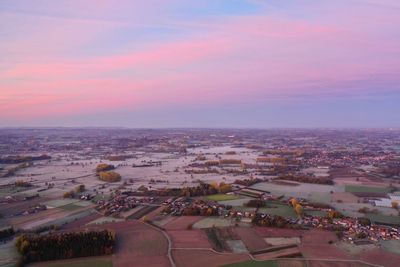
[16, 230, 115, 263]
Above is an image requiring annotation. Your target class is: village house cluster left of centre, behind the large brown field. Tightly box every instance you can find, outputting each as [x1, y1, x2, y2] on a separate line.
[96, 194, 155, 216]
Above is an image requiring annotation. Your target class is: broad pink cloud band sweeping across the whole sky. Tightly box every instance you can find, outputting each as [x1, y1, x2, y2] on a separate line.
[0, 6, 400, 121]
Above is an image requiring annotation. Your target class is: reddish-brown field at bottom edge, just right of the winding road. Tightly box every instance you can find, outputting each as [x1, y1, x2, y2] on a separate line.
[172, 249, 250, 267]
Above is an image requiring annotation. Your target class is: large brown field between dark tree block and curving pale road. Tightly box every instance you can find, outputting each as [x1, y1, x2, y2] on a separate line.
[92, 221, 170, 267]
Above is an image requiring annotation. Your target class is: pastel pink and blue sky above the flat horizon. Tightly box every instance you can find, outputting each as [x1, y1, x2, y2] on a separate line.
[0, 0, 400, 128]
